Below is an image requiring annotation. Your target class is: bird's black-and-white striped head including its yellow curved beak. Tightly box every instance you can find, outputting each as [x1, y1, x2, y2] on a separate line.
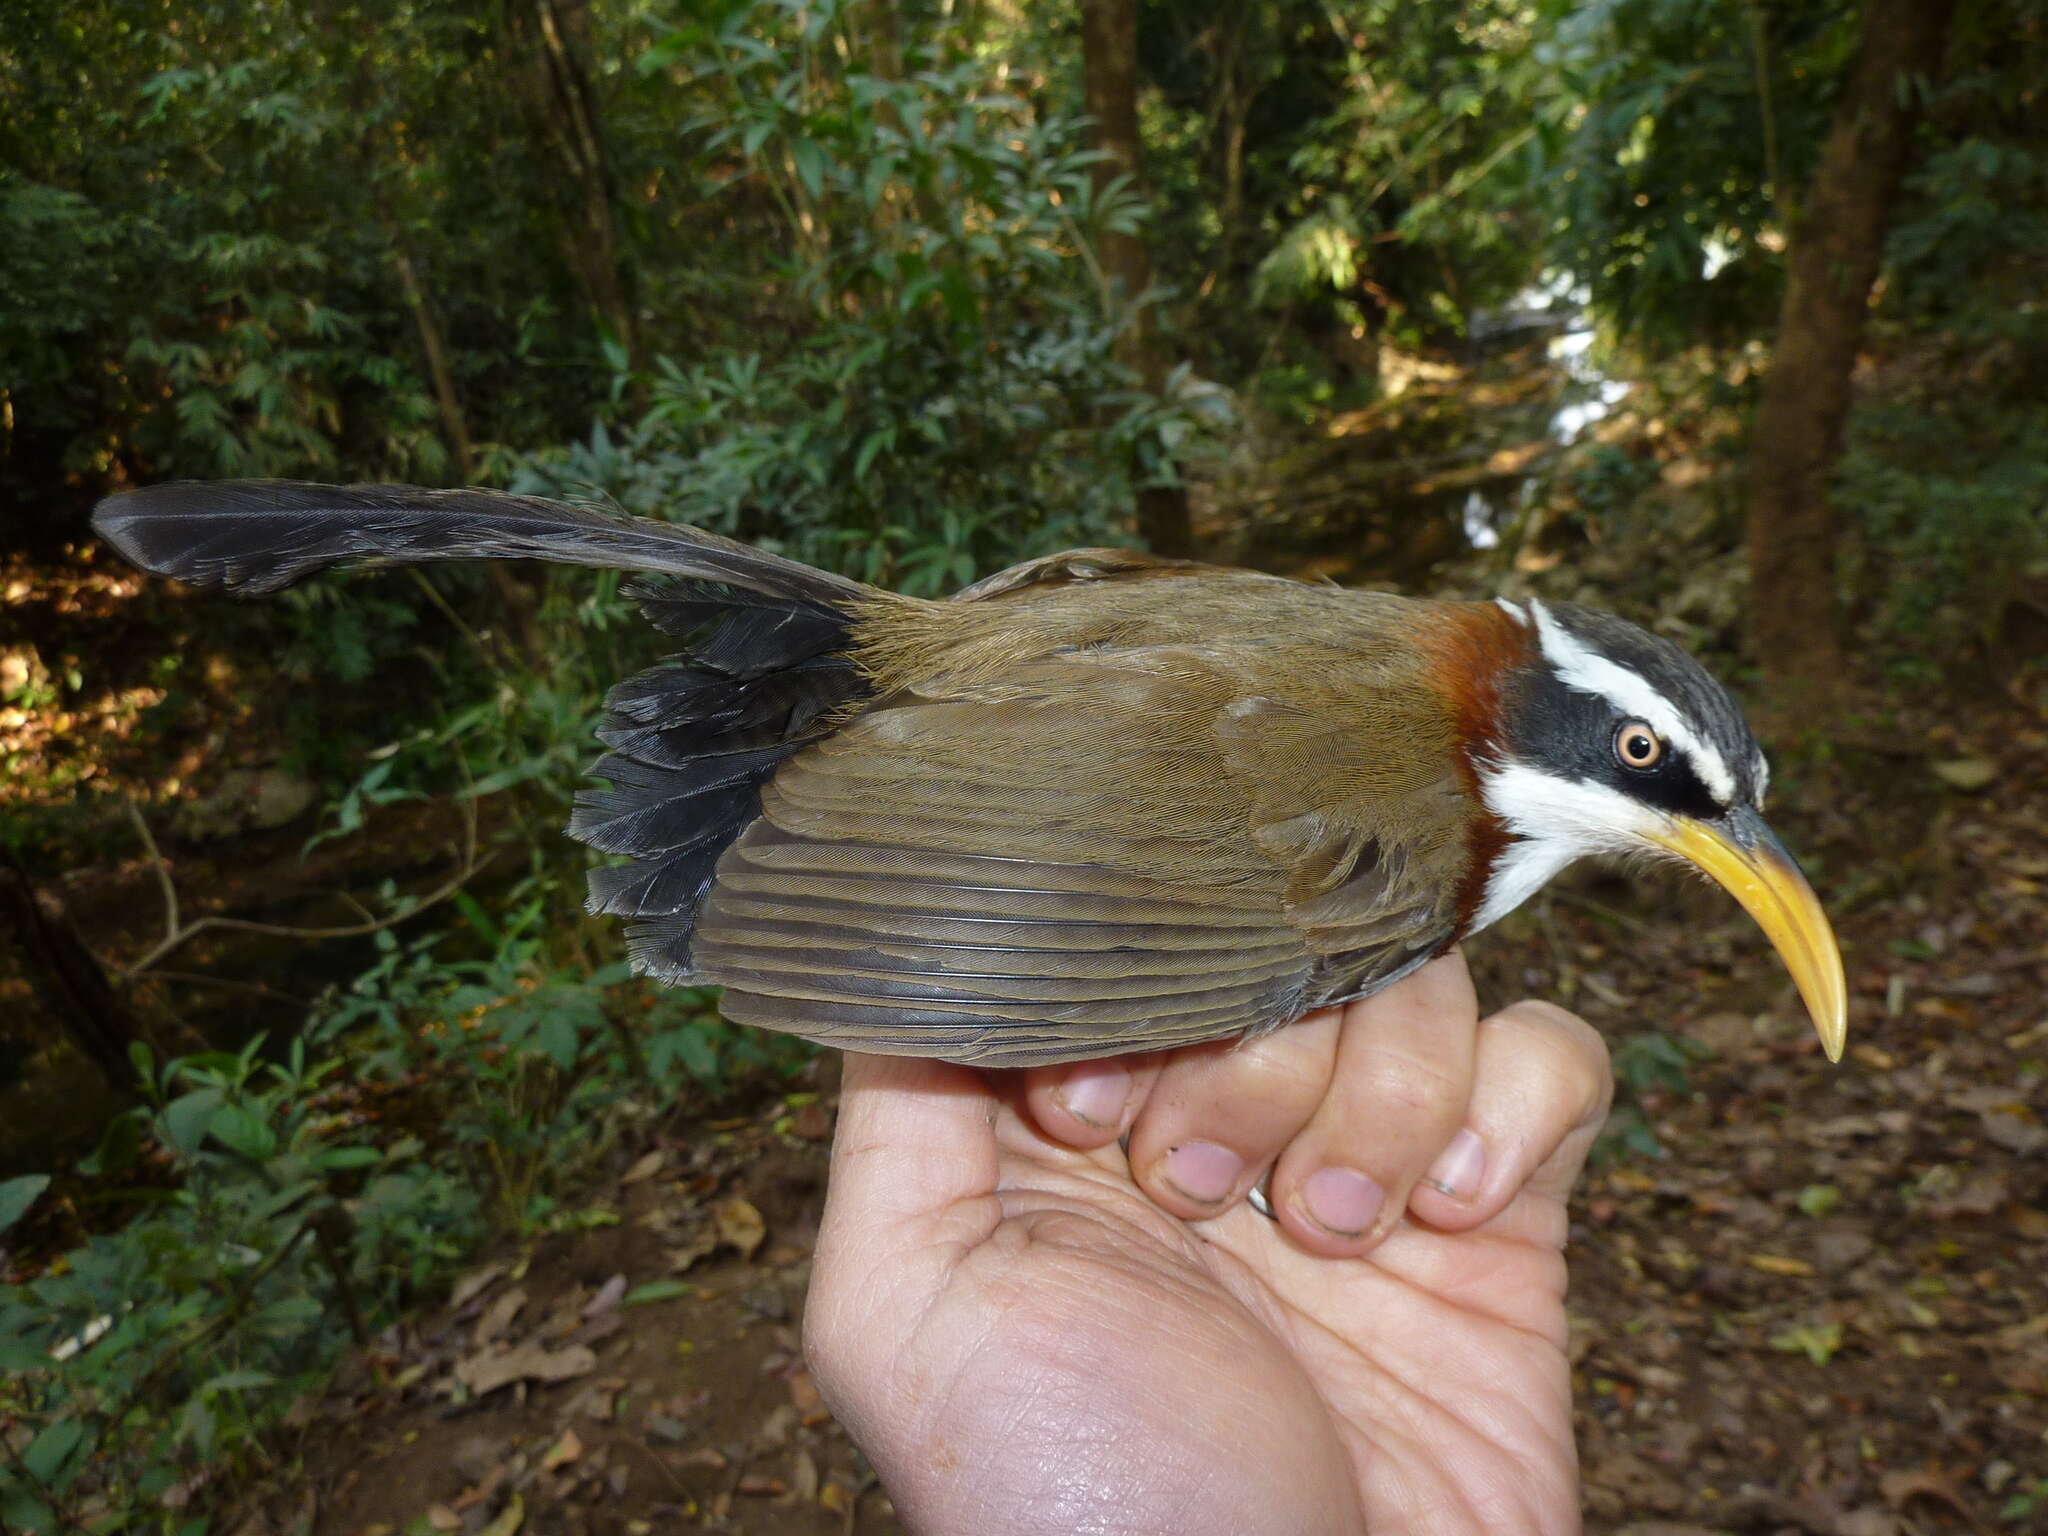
[1473, 598, 1847, 1061]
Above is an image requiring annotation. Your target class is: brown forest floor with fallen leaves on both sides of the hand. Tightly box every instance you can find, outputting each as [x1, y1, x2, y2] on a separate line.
[0, 475, 2048, 1536]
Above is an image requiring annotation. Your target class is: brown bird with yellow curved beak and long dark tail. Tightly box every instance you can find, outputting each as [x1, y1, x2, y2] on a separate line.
[92, 481, 1847, 1067]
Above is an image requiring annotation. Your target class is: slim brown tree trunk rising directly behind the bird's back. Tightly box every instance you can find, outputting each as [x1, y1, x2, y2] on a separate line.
[1081, 0, 1194, 555]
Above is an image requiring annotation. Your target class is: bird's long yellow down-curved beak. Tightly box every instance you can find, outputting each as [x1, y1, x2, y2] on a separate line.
[1645, 809, 1849, 1061]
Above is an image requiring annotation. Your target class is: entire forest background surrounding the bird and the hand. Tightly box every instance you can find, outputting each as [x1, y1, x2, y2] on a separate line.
[0, 0, 2048, 1536]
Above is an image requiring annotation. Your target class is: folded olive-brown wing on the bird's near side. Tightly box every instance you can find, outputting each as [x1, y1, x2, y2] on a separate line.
[694, 630, 1474, 1065]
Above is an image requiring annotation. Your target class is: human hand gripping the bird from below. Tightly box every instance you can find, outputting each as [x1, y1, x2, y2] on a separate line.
[805, 956, 1612, 1536]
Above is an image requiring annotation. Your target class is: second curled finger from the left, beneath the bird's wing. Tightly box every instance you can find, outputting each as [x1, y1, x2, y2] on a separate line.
[1130, 1008, 1337, 1221]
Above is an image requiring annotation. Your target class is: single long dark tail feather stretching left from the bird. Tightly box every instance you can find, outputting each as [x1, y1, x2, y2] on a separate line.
[92, 479, 870, 608]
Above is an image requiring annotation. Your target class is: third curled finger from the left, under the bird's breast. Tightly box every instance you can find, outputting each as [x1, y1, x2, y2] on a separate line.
[1272, 952, 1479, 1257]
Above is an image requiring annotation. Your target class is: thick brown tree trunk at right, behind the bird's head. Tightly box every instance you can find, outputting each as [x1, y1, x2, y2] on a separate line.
[1749, 0, 1954, 723]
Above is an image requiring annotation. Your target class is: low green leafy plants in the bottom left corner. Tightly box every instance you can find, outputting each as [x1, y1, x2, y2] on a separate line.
[0, 1042, 475, 1532]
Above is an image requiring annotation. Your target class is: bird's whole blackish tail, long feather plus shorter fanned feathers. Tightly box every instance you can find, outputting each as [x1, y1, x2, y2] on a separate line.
[92, 479, 874, 981]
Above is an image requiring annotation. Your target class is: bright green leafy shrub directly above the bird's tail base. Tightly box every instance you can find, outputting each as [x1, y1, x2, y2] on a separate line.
[518, 0, 1214, 594]
